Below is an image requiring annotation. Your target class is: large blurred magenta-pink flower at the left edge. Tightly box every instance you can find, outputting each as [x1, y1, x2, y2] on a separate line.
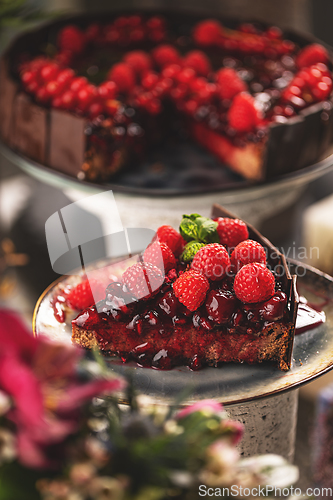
[0, 310, 124, 467]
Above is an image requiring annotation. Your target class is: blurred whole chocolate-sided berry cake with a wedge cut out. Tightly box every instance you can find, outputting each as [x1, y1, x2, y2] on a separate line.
[0, 13, 333, 182]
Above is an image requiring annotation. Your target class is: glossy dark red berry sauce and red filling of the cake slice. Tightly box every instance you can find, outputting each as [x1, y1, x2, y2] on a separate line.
[72, 270, 304, 370]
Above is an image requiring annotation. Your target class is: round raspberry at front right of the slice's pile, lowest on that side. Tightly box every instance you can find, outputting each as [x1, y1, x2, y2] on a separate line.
[234, 262, 275, 304]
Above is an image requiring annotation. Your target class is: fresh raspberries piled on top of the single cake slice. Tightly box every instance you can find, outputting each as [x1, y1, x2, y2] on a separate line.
[122, 217, 275, 312]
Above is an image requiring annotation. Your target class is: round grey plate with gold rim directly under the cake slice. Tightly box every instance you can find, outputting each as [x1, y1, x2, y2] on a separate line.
[33, 261, 333, 404]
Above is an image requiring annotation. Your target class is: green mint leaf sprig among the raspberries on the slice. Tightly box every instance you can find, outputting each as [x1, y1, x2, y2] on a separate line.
[179, 214, 220, 263]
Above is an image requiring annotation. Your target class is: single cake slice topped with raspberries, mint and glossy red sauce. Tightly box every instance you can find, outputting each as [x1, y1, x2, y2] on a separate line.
[72, 205, 297, 371]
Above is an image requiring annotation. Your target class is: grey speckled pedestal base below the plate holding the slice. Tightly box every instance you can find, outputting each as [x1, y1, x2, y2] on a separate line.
[226, 390, 299, 462]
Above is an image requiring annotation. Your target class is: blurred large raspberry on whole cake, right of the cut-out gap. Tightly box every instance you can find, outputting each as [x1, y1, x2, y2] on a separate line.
[228, 92, 260, 132]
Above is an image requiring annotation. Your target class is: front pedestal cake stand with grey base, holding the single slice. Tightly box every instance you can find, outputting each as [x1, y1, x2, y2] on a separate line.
[33, 261, 333, 460]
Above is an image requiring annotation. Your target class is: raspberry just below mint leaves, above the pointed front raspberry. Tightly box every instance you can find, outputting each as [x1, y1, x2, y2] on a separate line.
[191, 243, 230, 281]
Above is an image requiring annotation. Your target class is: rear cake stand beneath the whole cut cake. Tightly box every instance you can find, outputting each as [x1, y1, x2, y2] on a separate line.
[0, 142, 333, 229]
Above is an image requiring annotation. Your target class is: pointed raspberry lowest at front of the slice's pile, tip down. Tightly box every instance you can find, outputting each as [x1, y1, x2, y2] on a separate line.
[173, 269, 209, 311]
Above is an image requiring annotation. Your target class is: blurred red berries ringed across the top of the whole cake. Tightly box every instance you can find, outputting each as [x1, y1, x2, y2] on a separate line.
[20, 16, 332, 134]
